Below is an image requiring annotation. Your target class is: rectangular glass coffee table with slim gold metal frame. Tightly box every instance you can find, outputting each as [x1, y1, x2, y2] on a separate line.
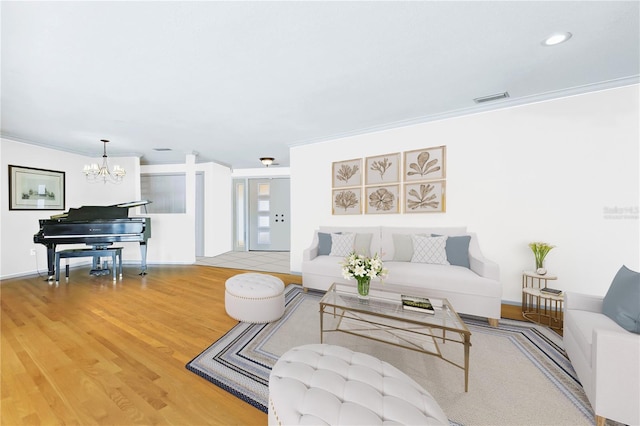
[320, 283, 471, 392]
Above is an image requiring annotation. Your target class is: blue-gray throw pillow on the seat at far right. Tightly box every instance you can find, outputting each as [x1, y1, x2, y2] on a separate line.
[602, 265, 640, 334]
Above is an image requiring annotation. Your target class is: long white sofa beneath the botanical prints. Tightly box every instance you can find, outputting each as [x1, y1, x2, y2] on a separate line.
[302, 226, 502, 326]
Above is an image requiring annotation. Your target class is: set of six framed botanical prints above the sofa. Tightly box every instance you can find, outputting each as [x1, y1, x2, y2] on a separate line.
[331, 145, 446, 215]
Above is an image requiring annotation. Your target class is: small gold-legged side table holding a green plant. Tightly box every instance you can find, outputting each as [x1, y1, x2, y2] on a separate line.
[522, 271, 564, 332]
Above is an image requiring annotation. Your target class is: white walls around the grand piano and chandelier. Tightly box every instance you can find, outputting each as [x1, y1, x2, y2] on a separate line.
[0, 139, 232, 278]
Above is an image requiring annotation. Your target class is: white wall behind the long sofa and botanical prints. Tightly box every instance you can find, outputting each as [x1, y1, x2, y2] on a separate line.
[291, 85, 640, 302]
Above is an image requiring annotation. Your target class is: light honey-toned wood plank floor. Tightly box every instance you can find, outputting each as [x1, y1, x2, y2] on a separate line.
[0, 266, 521, 425]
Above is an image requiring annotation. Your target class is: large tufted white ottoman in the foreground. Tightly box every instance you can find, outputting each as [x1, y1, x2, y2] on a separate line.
[268, 344, 449, 426]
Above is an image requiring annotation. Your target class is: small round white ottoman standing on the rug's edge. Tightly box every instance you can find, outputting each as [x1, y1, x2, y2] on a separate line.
[224, 273, 284, 323]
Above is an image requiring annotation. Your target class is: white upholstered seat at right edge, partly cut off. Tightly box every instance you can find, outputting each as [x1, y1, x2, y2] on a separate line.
[563, 292, 640, 426]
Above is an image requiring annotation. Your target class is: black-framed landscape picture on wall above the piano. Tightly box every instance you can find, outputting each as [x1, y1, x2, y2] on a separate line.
[9, 165, 65, 210]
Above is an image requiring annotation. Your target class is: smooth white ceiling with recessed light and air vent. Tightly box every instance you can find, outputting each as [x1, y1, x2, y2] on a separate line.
[0, 1, 640, 168]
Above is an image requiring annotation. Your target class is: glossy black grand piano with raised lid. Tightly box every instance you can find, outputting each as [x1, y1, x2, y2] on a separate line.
[33, 200, 151, 279]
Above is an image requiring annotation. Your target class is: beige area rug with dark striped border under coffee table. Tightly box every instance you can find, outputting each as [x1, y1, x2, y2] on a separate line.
[186, 285, 594, 426]
